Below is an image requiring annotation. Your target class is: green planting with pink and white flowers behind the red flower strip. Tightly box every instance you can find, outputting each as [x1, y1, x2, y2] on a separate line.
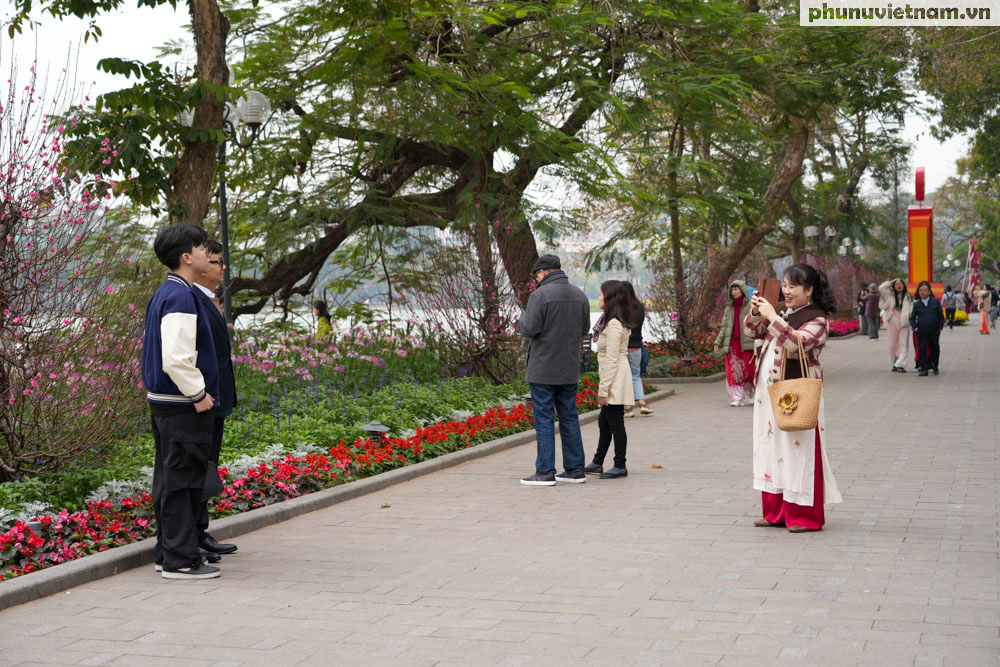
[0, 327, 527, 520]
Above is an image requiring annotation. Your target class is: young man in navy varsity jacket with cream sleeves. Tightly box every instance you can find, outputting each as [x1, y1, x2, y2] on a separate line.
[142, 224, 219, 579]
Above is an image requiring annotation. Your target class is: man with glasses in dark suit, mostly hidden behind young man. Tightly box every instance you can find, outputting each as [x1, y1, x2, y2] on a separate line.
[192, 240, 237, 563]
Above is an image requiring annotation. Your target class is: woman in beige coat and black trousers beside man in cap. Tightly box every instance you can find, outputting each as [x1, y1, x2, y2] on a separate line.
[584, 280, 635, 479]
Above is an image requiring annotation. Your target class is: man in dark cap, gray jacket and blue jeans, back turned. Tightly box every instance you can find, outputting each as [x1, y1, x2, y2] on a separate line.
[518, 255, 590, 486]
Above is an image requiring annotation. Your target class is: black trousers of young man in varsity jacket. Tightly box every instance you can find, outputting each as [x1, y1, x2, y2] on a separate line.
[150, 404, 215, 570]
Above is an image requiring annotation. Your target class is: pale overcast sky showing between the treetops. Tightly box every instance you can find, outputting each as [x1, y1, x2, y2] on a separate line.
[0, 3, 969, 193]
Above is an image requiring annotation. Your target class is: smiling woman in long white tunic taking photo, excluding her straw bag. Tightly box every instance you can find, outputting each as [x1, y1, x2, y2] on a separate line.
[744, 264, 842, 533]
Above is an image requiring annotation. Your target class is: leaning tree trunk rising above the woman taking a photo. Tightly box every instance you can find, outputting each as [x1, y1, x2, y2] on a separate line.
[691, 117, 809, 327]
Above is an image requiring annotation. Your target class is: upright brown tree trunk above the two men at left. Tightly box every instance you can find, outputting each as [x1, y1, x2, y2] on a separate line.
[167, 0, 229, 225]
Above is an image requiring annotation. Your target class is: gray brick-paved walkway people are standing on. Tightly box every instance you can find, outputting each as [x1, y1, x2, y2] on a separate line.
[0, 326, 1000, 667]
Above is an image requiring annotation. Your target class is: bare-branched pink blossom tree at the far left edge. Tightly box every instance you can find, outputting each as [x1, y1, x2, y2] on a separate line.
[0, 60, 149, 481]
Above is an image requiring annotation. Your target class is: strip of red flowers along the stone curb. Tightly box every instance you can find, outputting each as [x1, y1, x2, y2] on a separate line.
[0, 377, 656, 581]
